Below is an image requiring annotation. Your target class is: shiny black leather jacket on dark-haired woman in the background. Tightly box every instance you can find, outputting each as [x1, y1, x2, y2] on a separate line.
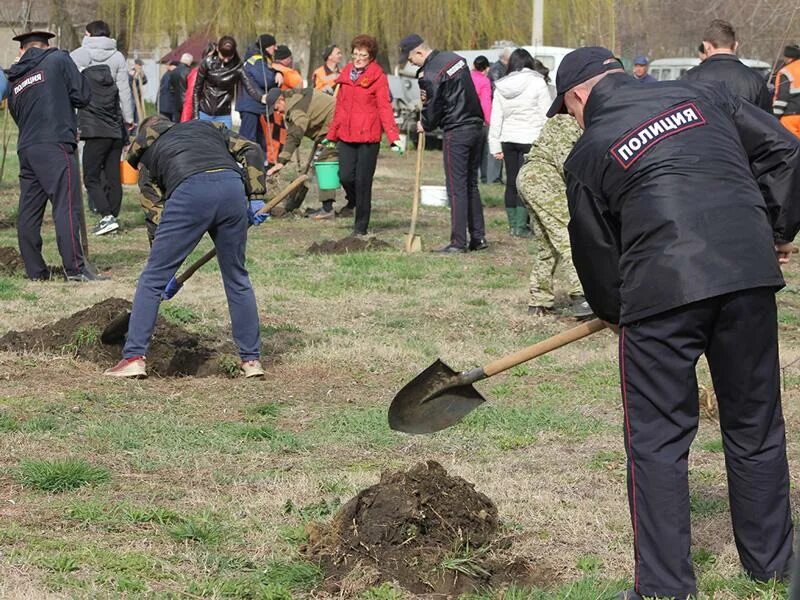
[192, 54, 260, 119]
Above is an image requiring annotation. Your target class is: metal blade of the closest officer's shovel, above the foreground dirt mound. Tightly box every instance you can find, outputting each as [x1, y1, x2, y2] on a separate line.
[389, 359, 486, 433]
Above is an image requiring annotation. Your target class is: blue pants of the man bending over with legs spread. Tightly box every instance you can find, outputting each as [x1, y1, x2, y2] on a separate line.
[122, 170, 261, 360]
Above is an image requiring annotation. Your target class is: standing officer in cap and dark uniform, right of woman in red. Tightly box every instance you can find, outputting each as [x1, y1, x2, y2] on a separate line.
[400, 33, 488, 254]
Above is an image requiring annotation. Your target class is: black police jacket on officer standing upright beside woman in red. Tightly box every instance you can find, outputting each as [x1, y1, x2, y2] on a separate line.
[417, 50, 483, 131]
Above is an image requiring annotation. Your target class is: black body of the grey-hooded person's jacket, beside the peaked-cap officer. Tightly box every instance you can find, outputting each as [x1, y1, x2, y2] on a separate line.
[78, 64, 125, 140]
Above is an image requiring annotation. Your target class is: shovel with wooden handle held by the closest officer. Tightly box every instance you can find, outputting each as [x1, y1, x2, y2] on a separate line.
[389, 319, 605, 433]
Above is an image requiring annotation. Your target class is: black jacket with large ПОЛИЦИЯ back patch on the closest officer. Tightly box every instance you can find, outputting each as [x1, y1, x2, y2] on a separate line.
[564, 73, 800, 324]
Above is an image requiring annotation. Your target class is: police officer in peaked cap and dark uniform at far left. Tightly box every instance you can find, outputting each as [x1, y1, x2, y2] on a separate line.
[6, 31, 107, 281]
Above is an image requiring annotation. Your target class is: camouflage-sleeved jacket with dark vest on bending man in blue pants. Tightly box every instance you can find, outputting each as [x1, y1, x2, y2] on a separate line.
[127, 118, 267, 198]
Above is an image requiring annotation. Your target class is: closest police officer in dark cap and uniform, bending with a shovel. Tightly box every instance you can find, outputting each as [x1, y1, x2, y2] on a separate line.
[548, 47, 800, 598]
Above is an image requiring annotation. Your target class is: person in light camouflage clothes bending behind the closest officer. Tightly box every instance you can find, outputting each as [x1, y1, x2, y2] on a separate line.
[517, 115, 588, 316]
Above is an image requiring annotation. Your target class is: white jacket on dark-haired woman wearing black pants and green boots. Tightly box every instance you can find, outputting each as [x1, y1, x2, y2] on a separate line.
[489, 69, 551, 154]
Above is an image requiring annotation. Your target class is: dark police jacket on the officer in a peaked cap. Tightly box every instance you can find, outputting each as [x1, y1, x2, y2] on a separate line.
[6, 48, 91, 150]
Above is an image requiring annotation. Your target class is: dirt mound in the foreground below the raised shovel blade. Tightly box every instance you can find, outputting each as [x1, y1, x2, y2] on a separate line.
[304, 461, 552, 596]
